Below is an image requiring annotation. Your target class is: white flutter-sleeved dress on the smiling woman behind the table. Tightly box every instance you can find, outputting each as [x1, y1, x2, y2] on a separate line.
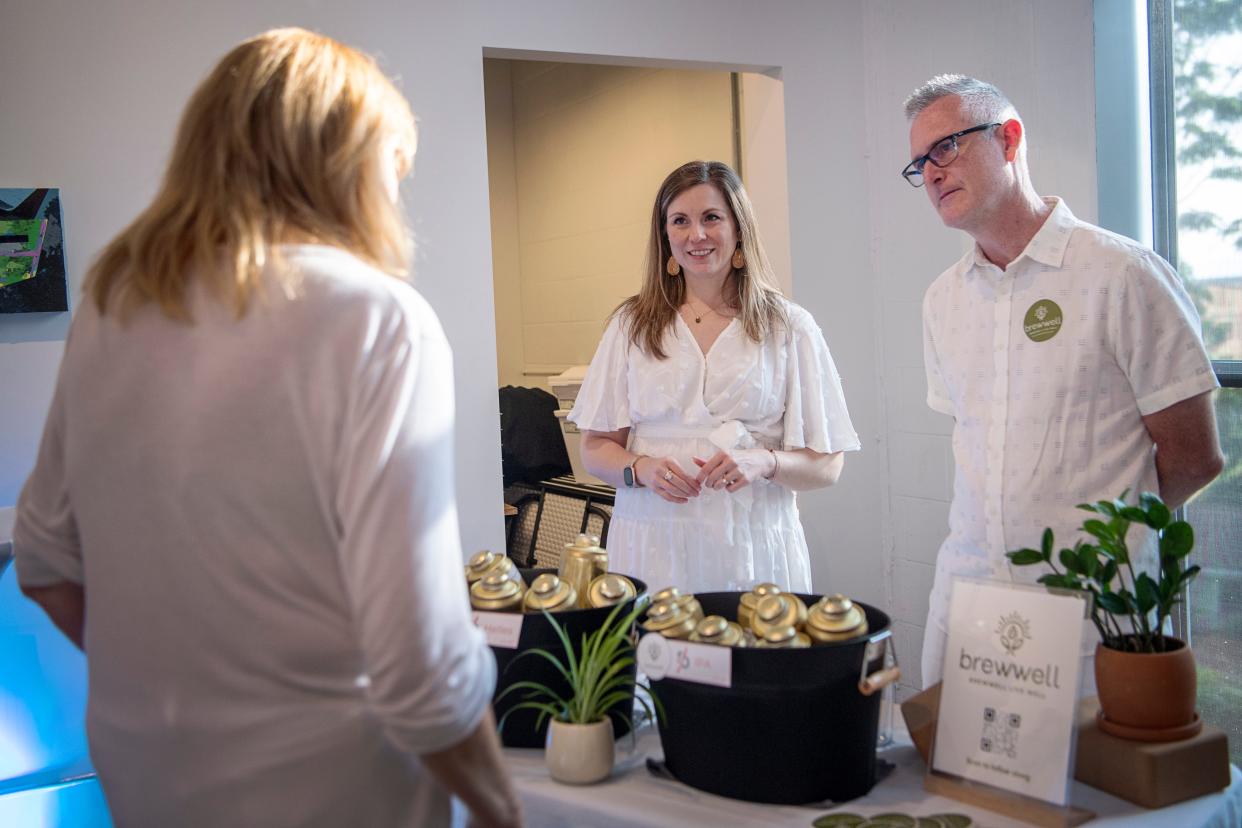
[569, 303, 859, 592]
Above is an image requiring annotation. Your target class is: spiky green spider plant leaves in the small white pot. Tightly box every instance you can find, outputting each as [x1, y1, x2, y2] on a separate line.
[497, 601, 663, 730]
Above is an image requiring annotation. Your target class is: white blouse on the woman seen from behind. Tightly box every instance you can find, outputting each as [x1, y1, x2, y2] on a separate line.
[14, 246, 496, 828]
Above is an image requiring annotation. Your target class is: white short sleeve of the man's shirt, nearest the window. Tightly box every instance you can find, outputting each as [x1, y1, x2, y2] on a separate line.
[1109, 251, 1218, 416]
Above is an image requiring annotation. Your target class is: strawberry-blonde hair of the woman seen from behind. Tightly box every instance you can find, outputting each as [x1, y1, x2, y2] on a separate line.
[86, 29, 416, 322]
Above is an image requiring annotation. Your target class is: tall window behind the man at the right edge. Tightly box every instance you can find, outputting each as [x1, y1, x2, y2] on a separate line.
[1149, 0, 1242, 763]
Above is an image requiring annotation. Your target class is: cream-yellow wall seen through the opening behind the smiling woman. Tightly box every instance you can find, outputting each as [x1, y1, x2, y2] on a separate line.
[488, 61, 733, 387]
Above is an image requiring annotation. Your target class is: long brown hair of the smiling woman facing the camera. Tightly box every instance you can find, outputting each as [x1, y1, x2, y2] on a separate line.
[612, 161, 786, 359]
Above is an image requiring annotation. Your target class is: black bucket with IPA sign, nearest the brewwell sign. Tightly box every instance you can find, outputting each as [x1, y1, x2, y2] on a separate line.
[652, 592, 892, 804]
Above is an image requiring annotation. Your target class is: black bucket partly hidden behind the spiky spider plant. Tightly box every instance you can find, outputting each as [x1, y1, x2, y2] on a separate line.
[492, 569, 647, 749]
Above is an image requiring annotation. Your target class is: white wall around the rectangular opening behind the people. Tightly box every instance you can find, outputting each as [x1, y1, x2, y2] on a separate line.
[0, 0, 1095, 685]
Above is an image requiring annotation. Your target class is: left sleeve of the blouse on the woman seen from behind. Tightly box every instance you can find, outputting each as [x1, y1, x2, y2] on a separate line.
[12, 348, 82, 587]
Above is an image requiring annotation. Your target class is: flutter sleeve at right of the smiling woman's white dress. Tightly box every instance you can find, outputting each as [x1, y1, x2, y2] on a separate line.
[781, 305, 861, 454]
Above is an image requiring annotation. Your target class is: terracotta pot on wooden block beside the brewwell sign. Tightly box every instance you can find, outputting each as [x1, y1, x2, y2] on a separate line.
[1095, 636, 1202, 741]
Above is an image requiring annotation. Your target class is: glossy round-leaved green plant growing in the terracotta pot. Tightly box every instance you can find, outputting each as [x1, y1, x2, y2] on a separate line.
[1006, 490, 1199, 653]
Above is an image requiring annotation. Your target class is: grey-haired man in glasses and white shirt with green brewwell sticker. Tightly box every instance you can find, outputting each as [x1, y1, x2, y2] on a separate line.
[902, 74, 1223, 690]
